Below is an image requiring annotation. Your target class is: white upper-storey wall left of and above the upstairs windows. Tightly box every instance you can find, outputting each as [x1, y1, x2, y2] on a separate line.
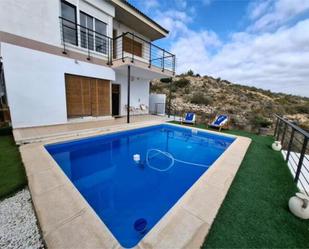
[0, 0, 115, 46]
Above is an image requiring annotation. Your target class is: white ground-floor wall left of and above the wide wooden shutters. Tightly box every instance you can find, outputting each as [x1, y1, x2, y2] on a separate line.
[1, 43, 115, 128]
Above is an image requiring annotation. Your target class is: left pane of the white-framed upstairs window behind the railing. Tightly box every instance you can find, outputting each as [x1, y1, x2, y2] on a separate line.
[80, 12, 94, 50]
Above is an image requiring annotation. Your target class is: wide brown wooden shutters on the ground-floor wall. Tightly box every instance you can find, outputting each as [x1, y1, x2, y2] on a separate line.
[65, 75, 110, 118]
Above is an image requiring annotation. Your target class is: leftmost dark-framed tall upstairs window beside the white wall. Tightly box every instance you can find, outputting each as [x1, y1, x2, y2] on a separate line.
[61, 1, 78, 46]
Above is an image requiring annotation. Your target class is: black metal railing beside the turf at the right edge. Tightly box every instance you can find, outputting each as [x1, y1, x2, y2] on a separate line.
[274, 115, 309, 194]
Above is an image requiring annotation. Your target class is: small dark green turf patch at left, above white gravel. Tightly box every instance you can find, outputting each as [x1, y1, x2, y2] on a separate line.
[0, 136, 27, 199]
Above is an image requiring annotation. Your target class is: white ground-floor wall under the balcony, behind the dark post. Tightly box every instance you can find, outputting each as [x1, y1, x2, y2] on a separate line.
[113, 74, 149, 115]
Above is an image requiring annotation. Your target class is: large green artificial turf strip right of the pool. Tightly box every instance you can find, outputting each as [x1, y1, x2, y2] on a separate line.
[170, 125, 309, 248]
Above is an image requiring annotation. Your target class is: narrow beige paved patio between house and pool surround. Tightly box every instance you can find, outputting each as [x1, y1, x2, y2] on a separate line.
[13, 115, 169, 144]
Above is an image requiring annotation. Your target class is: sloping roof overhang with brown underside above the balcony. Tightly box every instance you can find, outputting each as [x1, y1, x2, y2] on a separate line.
[110, 0, 169, 41]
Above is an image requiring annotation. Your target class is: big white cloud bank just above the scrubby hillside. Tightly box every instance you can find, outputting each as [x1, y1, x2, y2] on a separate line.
[172, 19, 309, 96]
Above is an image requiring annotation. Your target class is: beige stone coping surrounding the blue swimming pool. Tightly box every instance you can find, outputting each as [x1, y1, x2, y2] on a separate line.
[20, 121, 251, 249]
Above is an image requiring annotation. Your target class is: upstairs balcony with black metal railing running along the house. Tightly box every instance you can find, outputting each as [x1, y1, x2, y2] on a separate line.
[59, 17, 176, 76]
